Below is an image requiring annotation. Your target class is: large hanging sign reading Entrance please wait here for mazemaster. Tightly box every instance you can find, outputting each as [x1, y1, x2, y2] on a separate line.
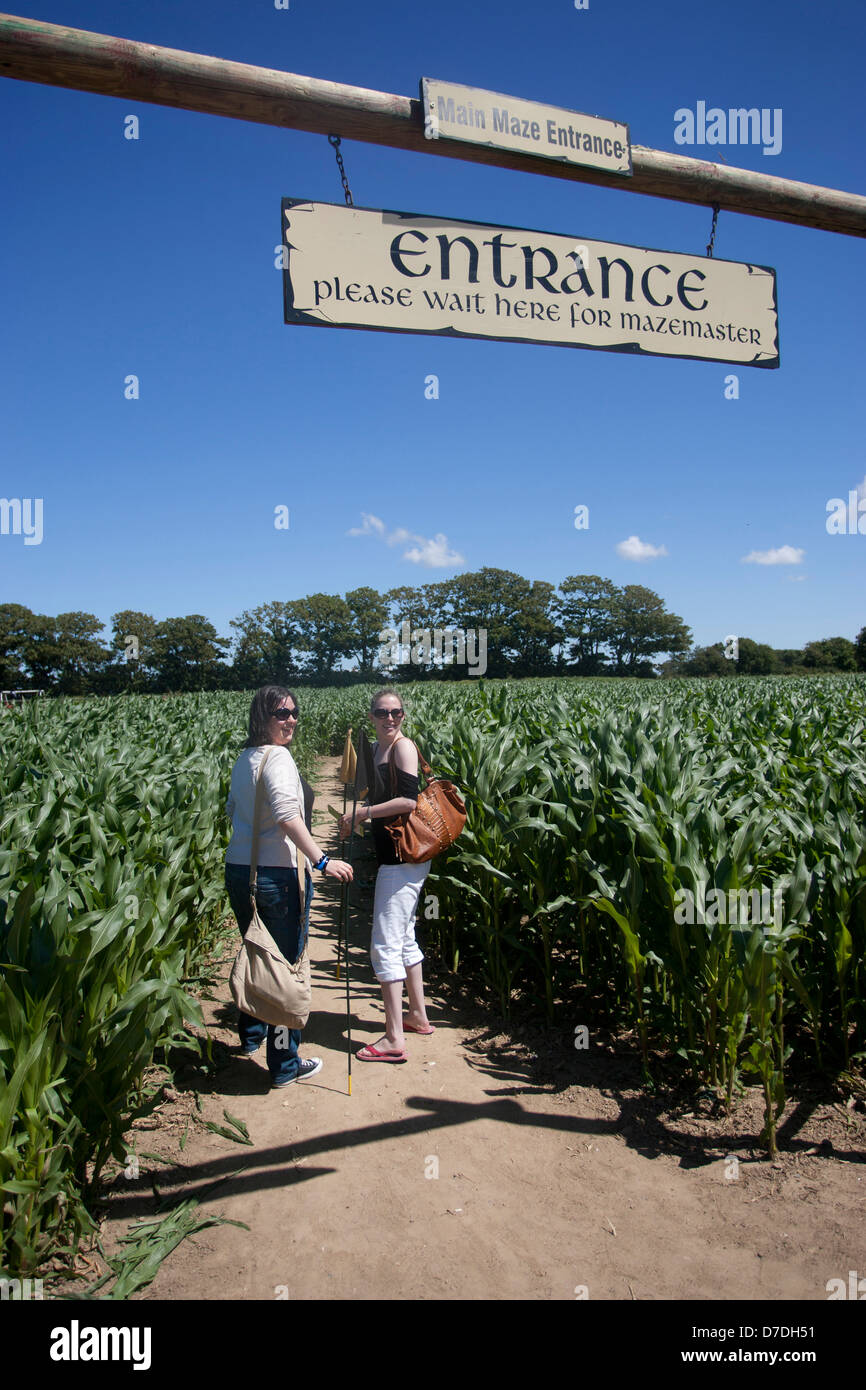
[282, 197, 778, 367]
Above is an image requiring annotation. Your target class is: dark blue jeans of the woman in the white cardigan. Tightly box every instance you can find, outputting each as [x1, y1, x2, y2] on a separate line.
[225, 863, 313, 1081]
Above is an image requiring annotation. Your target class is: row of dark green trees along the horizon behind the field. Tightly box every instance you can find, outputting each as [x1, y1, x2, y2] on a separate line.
[0, 569, 866, 695]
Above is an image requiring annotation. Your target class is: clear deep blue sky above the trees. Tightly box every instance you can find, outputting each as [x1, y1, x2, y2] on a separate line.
[0, 0, 866, 646]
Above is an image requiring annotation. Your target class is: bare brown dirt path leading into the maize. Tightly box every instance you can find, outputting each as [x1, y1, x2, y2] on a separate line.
[104, 759, 866, 1300]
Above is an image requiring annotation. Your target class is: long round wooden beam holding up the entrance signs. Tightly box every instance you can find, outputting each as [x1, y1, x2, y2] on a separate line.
[0, 14, 866, 236]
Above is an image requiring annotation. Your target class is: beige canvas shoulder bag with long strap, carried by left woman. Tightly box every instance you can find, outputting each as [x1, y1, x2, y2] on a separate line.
[229, 748, 313, 1029]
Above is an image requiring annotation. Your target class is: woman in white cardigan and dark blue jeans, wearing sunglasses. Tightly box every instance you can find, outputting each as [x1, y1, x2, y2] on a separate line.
[225, 685, 352, 1087]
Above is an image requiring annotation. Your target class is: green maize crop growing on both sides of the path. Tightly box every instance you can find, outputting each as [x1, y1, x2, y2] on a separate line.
[0, 677, 866, 1273]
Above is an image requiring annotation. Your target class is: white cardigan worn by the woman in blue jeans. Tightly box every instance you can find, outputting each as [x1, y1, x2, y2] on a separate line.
[225, 744, 303, 869]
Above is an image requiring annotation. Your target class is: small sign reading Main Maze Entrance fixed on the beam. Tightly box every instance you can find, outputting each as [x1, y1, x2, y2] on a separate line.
[421, 78, 631, 175]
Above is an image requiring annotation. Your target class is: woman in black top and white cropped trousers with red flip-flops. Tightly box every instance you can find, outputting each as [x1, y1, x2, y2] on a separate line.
[339, 689, 434, 1062]
